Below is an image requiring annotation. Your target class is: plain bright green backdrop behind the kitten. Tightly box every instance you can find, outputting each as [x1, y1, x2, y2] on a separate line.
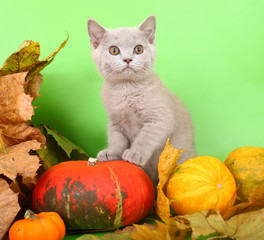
[0, 0, 264, 161]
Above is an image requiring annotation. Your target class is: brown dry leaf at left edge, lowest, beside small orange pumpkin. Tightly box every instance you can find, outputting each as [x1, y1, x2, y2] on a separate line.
[0, 178, 20, 239]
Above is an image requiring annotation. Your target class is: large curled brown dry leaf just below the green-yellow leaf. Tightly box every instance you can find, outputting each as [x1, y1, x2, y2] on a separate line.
[0, 72, 46, 146]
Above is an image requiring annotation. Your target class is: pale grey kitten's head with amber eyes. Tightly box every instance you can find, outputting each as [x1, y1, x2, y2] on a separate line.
[88, 16, 156, 81]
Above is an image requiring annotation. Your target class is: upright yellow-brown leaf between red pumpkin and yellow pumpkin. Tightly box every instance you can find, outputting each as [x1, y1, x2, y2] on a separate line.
[156, 139, 183, 222]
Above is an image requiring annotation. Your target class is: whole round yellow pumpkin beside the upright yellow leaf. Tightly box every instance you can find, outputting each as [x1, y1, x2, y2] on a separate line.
[166, 156, 236, 215]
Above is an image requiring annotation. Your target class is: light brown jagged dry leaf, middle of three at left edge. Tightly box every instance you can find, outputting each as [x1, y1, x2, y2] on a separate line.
[0, 140, 40, 182]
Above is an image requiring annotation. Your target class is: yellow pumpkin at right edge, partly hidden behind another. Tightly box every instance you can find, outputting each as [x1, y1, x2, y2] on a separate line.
[225, 147, 264, 202]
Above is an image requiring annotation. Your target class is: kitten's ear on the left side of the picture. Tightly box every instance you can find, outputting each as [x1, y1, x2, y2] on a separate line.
[87, 18, 107, 48]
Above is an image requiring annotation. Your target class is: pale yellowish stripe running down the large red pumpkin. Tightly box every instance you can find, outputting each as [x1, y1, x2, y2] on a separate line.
[107, 166, 123, 228]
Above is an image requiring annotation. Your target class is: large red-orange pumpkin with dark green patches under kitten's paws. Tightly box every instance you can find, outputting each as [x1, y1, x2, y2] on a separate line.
[33, 161, 155, 229]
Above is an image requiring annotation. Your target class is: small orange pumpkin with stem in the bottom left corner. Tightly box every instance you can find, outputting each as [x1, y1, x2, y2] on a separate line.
[9, 210, 66, 240]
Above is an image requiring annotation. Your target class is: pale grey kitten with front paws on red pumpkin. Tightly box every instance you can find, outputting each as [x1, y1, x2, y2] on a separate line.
[88, 16, 196, 185]
